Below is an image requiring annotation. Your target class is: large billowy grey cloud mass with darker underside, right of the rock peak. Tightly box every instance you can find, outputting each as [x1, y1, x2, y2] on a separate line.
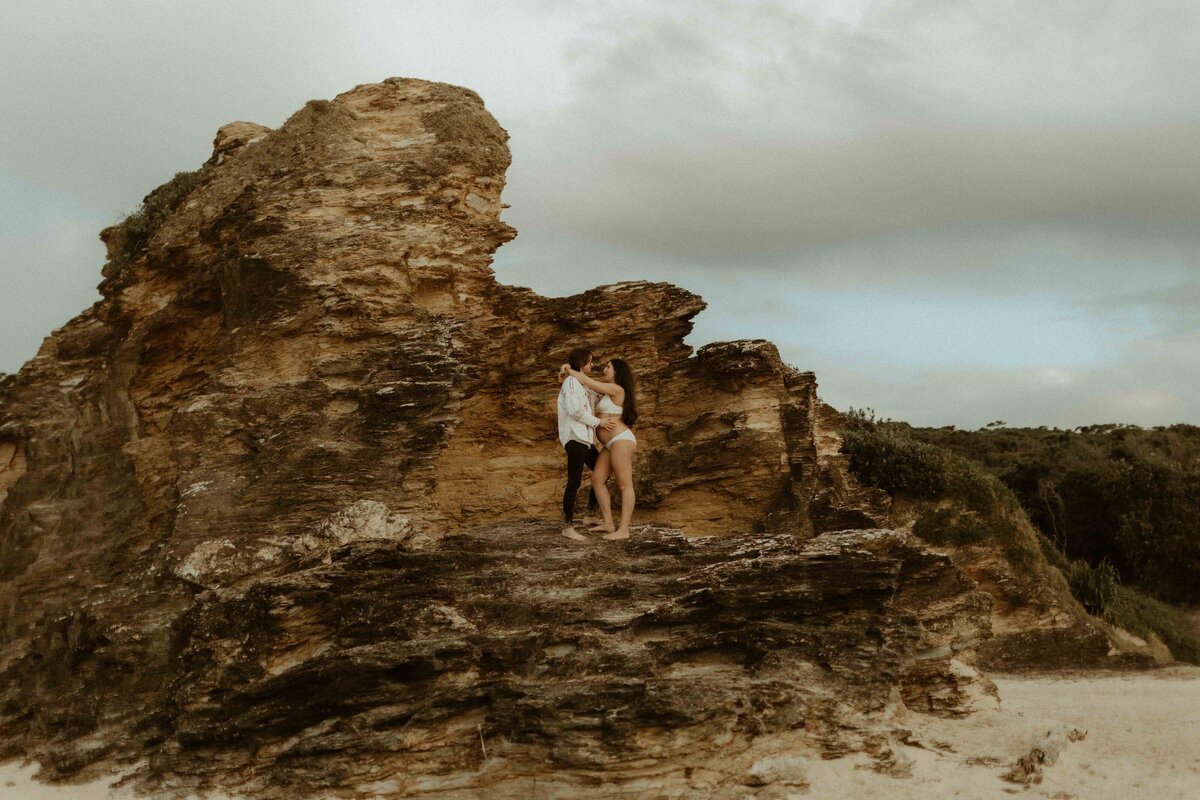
[499, 1, 1200, 259]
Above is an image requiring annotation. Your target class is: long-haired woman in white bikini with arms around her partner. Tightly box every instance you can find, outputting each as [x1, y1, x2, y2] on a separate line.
[563, 359, 637, 540]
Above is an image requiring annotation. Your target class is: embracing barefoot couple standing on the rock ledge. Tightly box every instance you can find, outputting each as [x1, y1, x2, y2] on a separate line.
[558, 348, 637, 541]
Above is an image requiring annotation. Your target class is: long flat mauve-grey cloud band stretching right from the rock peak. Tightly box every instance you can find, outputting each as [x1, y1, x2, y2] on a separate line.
[526, 124, 1200, 259]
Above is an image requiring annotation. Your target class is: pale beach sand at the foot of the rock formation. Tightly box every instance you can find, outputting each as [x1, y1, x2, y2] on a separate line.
[7, 667, 1200, 800]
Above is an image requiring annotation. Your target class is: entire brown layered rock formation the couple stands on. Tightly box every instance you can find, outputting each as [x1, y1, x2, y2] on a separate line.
[0, 79, 1108, 798]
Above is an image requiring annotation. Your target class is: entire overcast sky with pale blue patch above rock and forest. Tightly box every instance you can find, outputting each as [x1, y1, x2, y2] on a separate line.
[0, 0, 1200, 428]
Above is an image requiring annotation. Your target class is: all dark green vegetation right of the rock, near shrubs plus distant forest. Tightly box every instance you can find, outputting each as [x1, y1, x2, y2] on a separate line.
[842, 409, 1200, 663]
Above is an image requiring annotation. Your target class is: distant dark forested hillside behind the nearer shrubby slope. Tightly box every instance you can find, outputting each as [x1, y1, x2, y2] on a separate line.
[911, 425, 1200, 603]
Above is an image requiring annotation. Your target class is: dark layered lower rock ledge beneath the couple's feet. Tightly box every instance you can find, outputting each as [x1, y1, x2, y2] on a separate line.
[145, 522, 994, 798]
